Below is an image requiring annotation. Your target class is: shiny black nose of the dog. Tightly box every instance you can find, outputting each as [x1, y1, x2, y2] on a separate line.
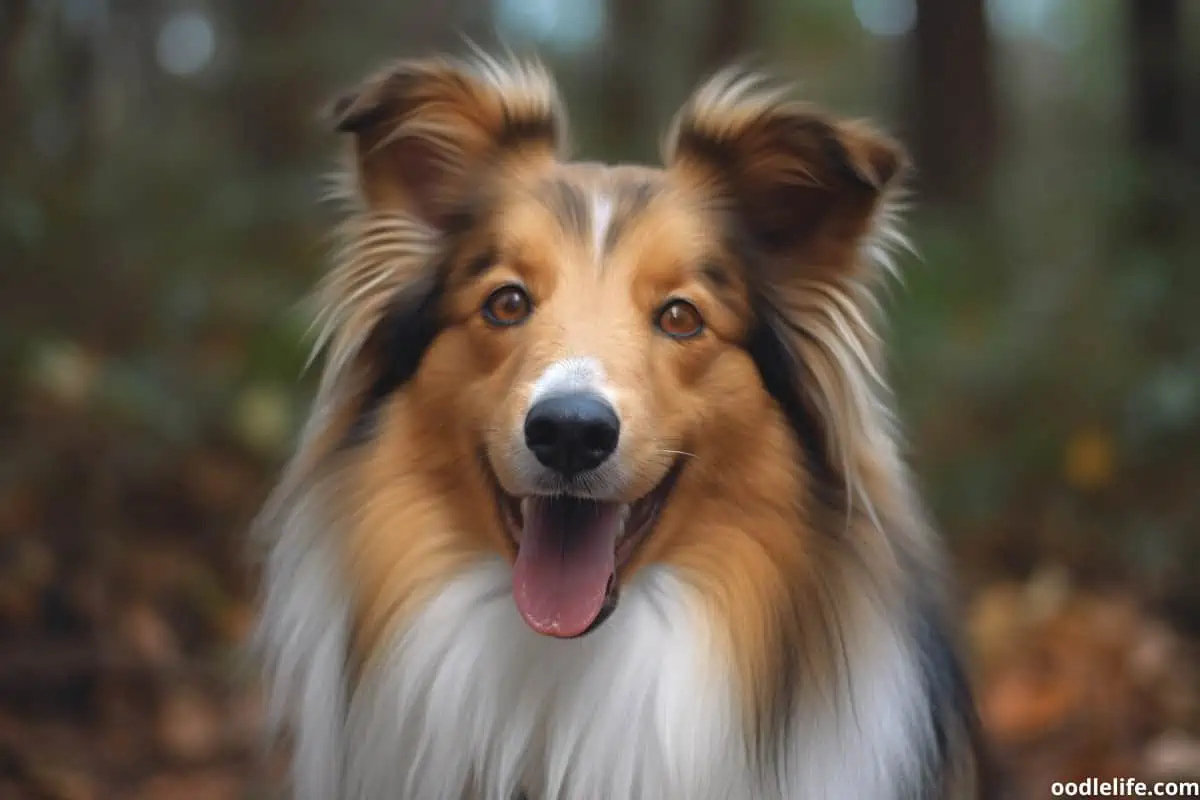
[526, 392, 620, 475]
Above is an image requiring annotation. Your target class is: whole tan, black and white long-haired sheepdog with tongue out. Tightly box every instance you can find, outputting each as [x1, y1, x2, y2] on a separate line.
[259, 55, 984, 800]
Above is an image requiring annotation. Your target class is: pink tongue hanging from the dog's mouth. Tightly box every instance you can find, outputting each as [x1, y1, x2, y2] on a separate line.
[512, 498, 620, 638]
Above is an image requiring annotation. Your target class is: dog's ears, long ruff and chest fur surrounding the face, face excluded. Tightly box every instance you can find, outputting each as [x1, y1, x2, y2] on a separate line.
[250, 56, 982, 800]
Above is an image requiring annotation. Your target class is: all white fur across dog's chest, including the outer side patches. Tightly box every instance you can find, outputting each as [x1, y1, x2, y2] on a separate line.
[267, 551, 929, 800]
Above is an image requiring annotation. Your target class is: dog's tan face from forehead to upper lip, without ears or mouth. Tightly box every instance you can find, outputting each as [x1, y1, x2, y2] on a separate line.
[412, 164, 729, 504]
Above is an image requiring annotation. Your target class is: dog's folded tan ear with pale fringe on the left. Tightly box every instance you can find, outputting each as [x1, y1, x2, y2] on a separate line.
[334, 56, 565, 230]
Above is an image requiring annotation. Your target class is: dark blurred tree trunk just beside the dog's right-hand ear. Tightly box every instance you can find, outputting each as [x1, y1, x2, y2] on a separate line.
[912, 0, 997, 205]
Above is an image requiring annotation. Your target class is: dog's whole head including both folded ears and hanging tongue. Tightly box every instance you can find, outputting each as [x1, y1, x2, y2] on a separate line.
[329, 57, 901, 637]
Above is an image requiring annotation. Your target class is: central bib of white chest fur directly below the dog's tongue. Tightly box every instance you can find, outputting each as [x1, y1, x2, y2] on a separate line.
[348, 561, 745, 800]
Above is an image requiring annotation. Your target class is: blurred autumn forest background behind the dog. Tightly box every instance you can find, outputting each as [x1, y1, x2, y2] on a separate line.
[0, 0, 1200, 800]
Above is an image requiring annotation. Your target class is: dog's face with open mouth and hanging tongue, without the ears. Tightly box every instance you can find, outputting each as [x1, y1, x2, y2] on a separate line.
[422, 164, 762, 636]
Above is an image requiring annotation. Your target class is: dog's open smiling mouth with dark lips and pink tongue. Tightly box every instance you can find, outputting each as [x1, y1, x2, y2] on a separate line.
[496, 463, 679, 638]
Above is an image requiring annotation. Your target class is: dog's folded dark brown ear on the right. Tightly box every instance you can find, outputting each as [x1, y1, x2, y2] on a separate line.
[665, 71, 907, 269]
